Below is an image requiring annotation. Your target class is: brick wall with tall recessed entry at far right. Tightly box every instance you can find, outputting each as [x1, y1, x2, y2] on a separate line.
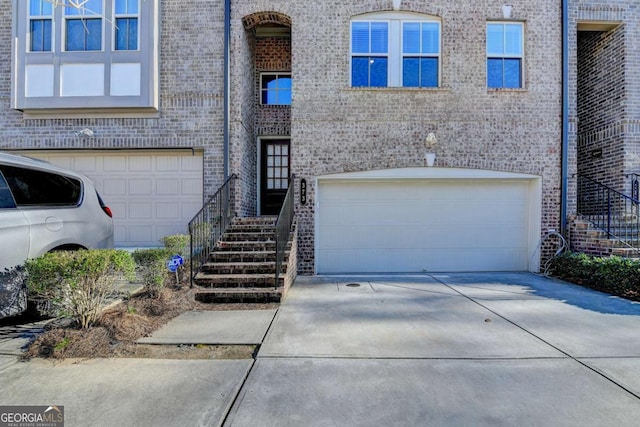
[569, 0, 640, 194]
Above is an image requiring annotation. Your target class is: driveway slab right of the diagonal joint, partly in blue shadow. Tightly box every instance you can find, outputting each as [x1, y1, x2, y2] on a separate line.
[443, 273, 640, 358]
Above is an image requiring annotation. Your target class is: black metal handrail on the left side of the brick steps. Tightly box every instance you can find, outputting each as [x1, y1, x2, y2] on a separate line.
[189, 174, 238, 286]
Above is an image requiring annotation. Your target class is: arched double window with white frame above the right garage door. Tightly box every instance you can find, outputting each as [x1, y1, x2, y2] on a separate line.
[351, 13, 441, 87]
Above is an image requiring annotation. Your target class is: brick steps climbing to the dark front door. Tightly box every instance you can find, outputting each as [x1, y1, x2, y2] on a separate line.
[194, 217, 286, 304]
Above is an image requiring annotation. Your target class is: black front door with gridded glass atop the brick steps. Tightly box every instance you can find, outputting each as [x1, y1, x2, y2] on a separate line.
[260, 139, 290, 215]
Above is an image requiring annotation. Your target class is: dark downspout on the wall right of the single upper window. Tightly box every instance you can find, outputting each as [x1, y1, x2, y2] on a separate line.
[560, 0, 569, 237]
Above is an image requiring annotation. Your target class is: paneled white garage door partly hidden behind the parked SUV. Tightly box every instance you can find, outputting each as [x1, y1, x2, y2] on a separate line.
[24, 150, 203, 247]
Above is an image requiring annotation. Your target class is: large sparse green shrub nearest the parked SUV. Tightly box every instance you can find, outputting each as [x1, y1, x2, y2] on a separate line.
[25, 249, 135, 328]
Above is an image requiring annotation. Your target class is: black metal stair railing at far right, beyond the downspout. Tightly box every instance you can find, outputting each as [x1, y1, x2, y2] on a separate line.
[577, 175, 640, 251]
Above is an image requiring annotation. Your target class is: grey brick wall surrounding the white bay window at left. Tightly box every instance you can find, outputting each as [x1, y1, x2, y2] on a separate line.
[0, 0, 224, 197]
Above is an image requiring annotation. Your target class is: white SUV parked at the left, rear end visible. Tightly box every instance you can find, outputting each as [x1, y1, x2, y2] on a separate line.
[0, 153, 113, 272]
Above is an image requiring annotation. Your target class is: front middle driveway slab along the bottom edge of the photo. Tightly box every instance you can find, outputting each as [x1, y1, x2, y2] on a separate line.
[225, 358, 640, 427]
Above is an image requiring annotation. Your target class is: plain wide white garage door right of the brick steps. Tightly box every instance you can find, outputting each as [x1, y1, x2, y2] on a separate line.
[316, 171, 540, 273]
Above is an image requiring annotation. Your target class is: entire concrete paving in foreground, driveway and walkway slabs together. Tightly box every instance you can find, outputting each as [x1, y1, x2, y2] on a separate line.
[0, 273, 640, 426]
